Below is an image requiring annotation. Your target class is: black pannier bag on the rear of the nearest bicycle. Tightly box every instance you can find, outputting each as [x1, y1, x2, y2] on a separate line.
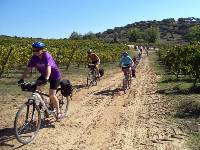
[60, 80, 73, 97]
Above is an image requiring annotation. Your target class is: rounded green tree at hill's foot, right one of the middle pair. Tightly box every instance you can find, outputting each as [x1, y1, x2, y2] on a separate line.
[143, 27, 160, 43]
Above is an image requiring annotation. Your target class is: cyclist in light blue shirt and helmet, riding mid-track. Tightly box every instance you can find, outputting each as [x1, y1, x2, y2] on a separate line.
[119, 52, 134, 76]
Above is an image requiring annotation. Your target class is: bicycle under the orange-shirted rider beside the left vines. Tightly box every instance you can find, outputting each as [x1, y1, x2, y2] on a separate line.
[87, 64, 100, 87]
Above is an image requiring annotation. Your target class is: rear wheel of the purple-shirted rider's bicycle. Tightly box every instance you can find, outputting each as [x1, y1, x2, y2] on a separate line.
[56, 88, 69, 116]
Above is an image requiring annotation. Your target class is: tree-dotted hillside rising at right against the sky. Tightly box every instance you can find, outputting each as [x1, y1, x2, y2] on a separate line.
[96, 17, 200, 44]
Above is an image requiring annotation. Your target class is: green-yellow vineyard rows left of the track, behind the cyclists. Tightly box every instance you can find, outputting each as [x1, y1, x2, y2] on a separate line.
[0, 37, 128, 77]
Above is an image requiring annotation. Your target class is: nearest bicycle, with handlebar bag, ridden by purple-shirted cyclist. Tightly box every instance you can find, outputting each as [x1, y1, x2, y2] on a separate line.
[14, 82, 69, 144]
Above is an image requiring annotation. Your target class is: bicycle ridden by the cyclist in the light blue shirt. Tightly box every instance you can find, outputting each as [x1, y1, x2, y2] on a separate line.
[123, 68, 132, 94]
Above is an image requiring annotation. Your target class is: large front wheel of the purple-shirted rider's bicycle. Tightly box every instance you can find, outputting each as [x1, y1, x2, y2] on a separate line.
[14, 102, 41, 144]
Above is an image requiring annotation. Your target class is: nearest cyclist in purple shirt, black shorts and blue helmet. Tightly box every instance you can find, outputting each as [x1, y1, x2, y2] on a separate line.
[18, 42, 63, 119]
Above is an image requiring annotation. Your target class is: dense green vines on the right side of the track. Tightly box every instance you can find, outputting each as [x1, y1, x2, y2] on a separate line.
[157, 42, 200, 85]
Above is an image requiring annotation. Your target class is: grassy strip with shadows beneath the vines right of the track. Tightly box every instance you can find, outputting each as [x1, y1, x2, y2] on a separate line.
[150, 52, 200, 150]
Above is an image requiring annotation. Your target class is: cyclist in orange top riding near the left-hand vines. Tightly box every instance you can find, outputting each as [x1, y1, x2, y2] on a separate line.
[87, 49, 100, 77]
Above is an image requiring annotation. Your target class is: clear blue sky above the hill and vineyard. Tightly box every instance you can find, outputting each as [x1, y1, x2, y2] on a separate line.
[0, 0, 200, 39]
